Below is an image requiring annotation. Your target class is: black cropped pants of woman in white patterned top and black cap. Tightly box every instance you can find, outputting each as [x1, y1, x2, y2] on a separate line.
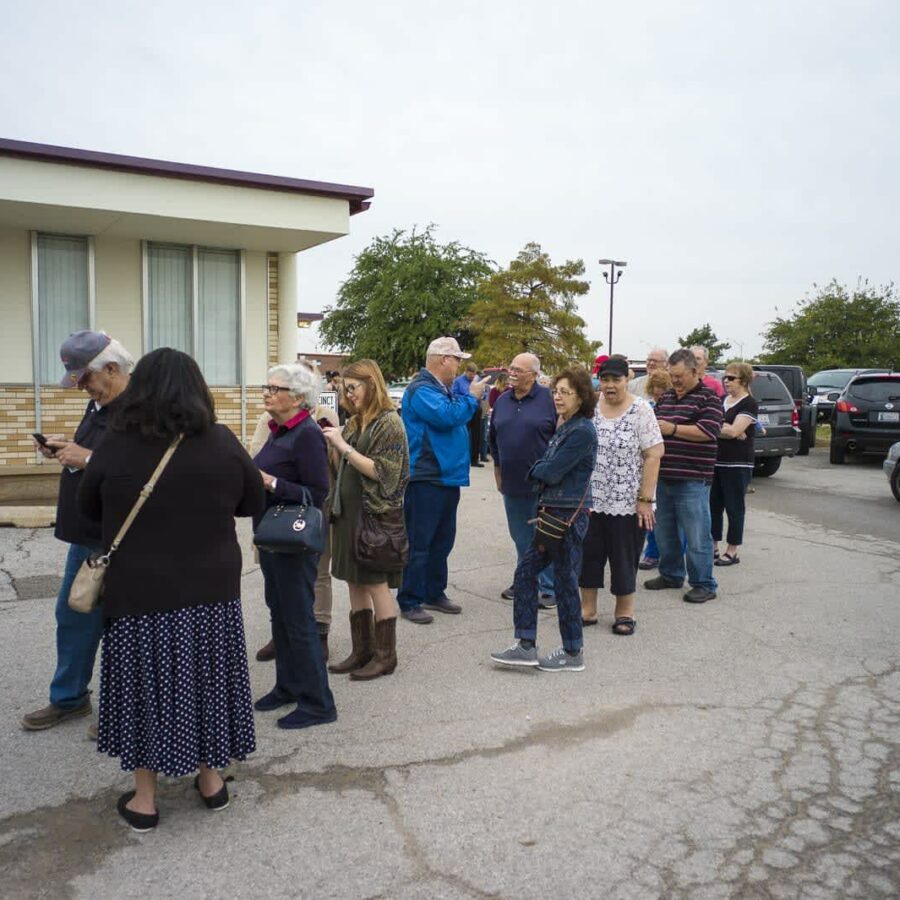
[578, 512, 645, 597]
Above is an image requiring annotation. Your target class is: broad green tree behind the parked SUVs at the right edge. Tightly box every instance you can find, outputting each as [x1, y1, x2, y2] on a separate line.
[761, 279, 900, 374]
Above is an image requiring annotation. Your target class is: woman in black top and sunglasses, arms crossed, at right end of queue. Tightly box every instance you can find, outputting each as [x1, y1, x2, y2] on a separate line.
[709, 363, 759, 566]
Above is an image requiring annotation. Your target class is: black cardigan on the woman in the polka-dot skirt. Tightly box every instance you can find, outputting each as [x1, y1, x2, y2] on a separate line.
[78, 425, 266, 618]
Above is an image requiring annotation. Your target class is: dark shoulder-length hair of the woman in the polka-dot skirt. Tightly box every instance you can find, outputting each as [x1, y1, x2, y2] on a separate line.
[110, 347, 216, 440]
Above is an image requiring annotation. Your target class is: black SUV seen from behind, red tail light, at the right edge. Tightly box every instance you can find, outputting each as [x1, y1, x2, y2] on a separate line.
[831, 373, 900, 465]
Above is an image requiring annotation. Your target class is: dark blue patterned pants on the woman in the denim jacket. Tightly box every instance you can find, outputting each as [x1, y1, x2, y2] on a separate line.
[513, 507, 588, 651]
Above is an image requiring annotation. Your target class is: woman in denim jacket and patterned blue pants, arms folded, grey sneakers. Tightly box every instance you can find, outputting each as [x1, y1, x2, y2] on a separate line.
[491, 367, 597, 672]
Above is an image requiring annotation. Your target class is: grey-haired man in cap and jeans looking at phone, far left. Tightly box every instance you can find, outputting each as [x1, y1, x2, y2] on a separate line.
[22, 331, 134, 736]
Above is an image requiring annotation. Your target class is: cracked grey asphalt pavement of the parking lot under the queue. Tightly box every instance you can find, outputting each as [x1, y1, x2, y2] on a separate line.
[0, 458, 900, 898]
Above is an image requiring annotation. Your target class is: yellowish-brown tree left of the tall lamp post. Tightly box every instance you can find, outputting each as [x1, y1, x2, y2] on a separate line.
[469, 243, 600, 372]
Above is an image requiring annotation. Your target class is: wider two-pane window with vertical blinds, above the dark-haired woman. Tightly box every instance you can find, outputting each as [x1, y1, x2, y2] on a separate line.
[145, 242, 241, 385]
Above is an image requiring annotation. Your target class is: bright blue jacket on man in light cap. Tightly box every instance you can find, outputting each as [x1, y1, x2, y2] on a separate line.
[400, 369, 478, 487]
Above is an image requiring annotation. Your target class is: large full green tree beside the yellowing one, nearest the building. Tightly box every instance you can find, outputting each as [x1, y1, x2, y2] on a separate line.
[320, 225, 492, 379]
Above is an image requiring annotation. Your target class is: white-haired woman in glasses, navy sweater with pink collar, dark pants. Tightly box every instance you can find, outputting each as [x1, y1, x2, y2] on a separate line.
[253, 363, 337, 728]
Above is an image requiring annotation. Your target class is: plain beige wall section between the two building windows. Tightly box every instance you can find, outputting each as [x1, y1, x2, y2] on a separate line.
[94, 235, 143, 356]
